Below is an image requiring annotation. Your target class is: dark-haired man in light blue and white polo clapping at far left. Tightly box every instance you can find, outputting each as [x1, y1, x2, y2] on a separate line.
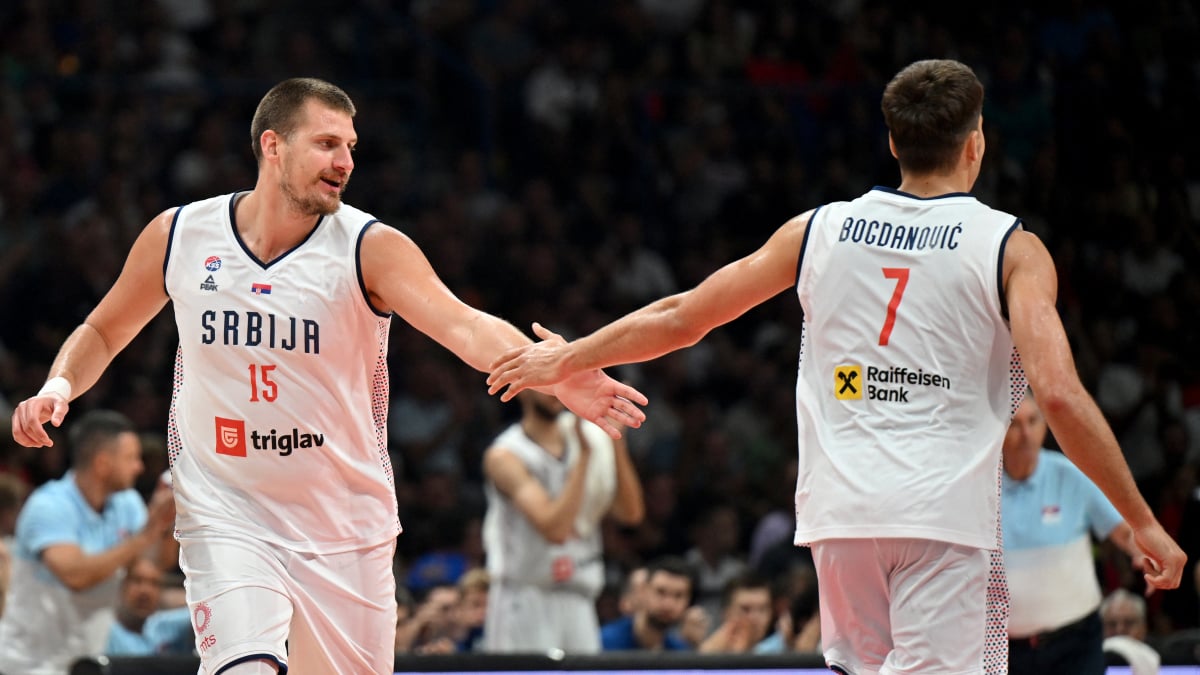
[0, 411, 175, 675]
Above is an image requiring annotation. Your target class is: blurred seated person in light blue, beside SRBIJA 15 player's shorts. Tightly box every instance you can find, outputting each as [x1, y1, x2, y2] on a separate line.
[104, 557, 196, 656]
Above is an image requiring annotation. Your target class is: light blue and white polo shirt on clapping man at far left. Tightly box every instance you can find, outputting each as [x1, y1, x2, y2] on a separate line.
[0, 471, 146, 674]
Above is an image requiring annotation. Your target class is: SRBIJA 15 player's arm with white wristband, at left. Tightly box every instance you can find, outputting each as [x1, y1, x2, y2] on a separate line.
[12, 209, 175, 448]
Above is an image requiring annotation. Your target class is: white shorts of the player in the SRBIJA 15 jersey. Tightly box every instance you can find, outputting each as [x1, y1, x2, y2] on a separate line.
[179, 536, 396, 675]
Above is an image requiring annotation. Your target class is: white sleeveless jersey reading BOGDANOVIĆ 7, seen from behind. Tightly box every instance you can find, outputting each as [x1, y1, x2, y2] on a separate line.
[796, 187, 1024, 549]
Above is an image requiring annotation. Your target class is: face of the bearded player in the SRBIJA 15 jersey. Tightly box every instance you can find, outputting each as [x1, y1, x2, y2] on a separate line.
[280, 100, 359, 216]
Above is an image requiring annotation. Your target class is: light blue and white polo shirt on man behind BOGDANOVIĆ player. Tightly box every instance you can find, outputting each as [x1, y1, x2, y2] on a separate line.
[1001, 449, 1123, 638]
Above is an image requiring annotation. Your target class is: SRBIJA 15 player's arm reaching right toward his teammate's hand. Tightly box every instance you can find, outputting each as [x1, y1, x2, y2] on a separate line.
[361, 223, 647, 438]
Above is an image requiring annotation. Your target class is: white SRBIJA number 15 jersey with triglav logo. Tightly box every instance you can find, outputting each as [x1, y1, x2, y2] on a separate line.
[164, 195, 400, 552]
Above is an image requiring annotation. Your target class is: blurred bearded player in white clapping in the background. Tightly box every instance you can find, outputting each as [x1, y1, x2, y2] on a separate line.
[484, 392, 646, 653]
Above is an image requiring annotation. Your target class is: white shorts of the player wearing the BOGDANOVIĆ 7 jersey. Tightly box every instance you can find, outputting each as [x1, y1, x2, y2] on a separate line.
[812, 539, 991, 675]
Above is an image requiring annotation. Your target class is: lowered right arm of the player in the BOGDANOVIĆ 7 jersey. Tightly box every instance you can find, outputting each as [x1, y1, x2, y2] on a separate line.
[1004, 232, 1187, 589]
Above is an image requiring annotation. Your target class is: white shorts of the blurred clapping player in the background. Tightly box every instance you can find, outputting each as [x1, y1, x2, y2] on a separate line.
[484, 583, 600, 653]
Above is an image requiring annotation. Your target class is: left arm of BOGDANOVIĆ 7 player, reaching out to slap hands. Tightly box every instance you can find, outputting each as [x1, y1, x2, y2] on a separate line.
[487, 211, 811, 401]
